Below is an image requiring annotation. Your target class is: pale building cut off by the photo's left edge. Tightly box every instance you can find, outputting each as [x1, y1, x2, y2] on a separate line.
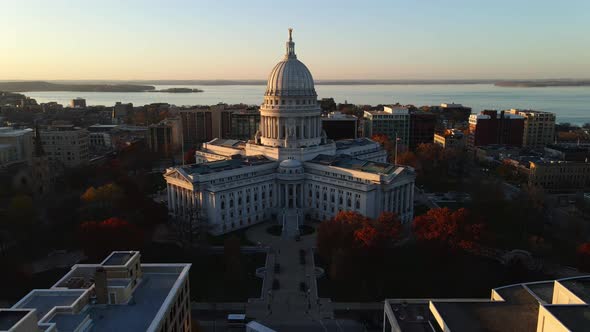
[0, 127, 33, 165]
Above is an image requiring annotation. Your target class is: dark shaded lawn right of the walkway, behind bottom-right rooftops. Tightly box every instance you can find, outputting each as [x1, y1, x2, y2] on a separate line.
[316, 245, 551, 302]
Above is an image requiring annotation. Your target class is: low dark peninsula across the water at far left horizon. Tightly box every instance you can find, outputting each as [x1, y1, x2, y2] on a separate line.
[0, 81, 156, 92]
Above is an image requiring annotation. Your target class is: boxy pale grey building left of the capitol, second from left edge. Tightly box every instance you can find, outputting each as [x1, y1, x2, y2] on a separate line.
[41, 125, 90, 167]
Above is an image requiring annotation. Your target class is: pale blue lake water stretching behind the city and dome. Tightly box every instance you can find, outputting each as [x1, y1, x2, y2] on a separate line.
[24, 84, 590, 124]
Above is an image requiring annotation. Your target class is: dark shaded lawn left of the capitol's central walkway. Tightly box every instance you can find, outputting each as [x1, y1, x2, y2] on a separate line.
[141, 245, 266, 302]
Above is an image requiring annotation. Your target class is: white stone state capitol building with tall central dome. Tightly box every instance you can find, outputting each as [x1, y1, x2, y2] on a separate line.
[164, 29, 416, 234]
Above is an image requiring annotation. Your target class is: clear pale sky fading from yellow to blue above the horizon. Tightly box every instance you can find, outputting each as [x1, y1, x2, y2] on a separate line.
[0, 0, 590, 80]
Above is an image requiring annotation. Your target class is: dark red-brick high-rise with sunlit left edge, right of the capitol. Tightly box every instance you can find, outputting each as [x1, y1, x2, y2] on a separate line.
[468, 110, 524, 148]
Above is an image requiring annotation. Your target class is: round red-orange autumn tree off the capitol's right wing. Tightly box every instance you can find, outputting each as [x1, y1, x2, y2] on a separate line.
[412, 208, 484, 249]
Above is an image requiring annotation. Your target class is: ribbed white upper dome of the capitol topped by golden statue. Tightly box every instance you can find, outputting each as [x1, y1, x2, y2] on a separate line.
[265, 29, 317, 97]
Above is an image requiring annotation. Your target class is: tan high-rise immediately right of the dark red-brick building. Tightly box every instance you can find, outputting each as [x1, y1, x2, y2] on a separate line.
[508, 109, 555, 148]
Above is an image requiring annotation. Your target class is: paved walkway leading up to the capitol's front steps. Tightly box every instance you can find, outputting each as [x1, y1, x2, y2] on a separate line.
[246, 220, 333, 325]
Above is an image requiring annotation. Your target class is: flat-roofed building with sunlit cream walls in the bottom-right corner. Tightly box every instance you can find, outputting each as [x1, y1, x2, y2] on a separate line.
[383, 276, 590, 332]
